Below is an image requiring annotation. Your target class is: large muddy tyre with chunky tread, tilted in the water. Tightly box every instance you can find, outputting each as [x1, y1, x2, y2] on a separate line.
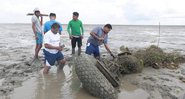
[75, 55, 118, 99]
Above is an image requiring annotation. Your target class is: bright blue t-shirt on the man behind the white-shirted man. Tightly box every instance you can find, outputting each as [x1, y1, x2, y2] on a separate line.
[44, 20, 62, 33]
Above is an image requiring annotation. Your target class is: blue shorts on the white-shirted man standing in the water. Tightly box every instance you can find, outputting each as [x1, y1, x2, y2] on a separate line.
[43, 49, 64, 66]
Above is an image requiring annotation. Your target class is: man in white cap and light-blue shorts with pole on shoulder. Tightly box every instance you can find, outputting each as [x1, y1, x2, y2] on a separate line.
[32, 8, 43, 59]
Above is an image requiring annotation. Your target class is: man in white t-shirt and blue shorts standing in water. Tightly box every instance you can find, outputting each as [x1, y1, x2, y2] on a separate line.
[43, 23, 65, 74]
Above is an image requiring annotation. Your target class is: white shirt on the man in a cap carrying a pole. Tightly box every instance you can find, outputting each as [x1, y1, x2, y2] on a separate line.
[32, 15, 42, 33]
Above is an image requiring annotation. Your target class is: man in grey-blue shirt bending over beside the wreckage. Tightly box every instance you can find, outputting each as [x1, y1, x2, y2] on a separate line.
[85, 24, 114, 59]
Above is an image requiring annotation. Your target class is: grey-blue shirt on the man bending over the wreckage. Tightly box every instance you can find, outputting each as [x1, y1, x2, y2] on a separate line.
[87, 27, 108, 46]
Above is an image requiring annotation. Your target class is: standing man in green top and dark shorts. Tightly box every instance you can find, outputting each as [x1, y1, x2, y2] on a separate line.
[67, 12, 84, 55]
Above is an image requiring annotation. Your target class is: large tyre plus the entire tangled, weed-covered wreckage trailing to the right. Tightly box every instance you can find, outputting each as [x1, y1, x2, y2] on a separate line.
[75, 46, 184, 99]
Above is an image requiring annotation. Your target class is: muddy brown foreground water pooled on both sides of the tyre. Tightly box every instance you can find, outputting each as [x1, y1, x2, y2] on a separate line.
[1, 65, 149, 99]
